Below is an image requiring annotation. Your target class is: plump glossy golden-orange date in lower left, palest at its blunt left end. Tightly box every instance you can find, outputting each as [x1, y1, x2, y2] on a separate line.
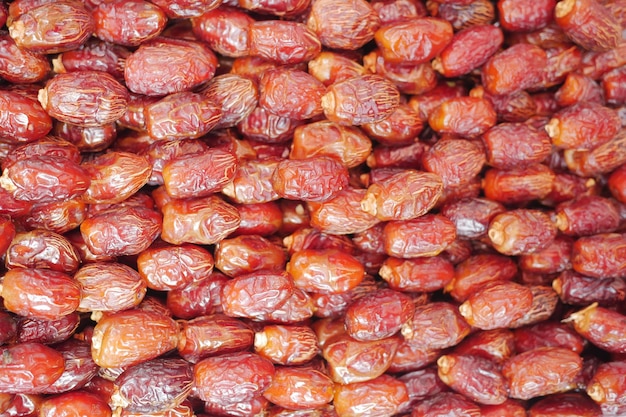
[91, 309, 180, 368]
